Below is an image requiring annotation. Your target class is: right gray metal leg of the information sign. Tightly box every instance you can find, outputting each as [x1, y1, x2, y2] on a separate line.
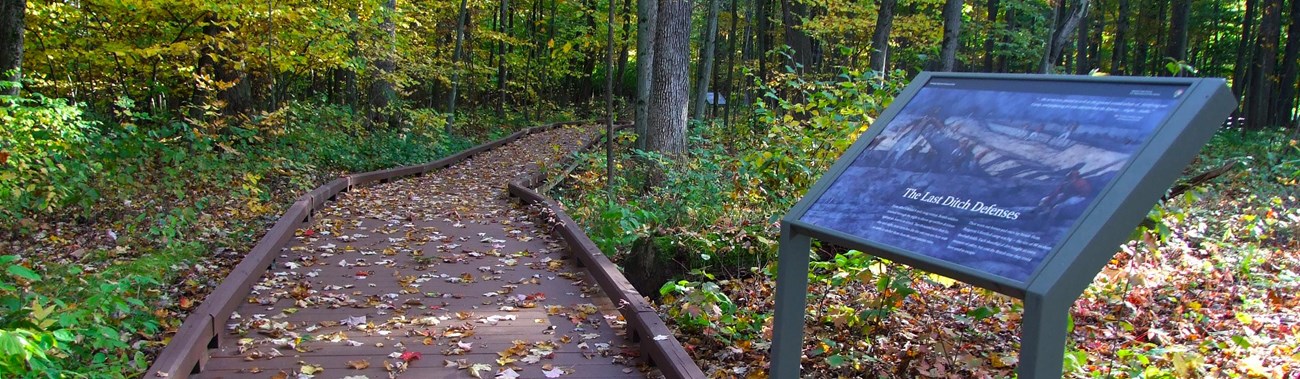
[1017, 293, 1074, 379]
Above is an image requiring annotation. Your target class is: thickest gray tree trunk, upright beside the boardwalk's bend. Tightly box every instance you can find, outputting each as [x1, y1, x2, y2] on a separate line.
[646, 0, 690, 157]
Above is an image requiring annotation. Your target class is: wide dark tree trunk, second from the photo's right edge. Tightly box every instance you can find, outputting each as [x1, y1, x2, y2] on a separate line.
[1245, 0, 1282, 128]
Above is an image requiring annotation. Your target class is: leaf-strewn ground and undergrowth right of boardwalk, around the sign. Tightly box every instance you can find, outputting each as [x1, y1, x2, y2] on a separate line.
[558, 73, 1300, 378]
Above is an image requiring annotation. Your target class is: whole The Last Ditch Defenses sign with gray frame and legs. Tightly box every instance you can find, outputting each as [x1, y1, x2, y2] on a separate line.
[772, 73, 1235, 378]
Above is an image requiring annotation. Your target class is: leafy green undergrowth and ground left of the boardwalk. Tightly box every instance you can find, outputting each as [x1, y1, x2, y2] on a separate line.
[0, 88, 563, 378]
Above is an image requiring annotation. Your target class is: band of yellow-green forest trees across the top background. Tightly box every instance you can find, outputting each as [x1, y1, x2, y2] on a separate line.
[0, 0, 1300, 132]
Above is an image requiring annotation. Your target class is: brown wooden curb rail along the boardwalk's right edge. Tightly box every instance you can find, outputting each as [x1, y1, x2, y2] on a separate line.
[508, 123, 707, 379]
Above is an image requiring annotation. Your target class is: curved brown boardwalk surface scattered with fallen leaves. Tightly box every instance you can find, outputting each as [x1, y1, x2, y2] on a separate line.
[192, 127, 646, 379]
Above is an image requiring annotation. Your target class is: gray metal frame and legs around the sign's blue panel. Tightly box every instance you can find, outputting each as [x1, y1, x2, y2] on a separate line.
[770, 73, 1236, 378]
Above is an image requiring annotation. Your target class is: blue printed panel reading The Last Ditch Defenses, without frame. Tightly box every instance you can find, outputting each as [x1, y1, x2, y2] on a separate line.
[801, 79, 1186, 282]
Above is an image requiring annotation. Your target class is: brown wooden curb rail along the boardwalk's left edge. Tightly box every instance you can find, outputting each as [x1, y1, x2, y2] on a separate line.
[144, 121, 587, 378]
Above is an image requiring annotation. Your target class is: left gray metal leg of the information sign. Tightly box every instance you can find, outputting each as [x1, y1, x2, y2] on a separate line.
[768, 228, 813, 379]
